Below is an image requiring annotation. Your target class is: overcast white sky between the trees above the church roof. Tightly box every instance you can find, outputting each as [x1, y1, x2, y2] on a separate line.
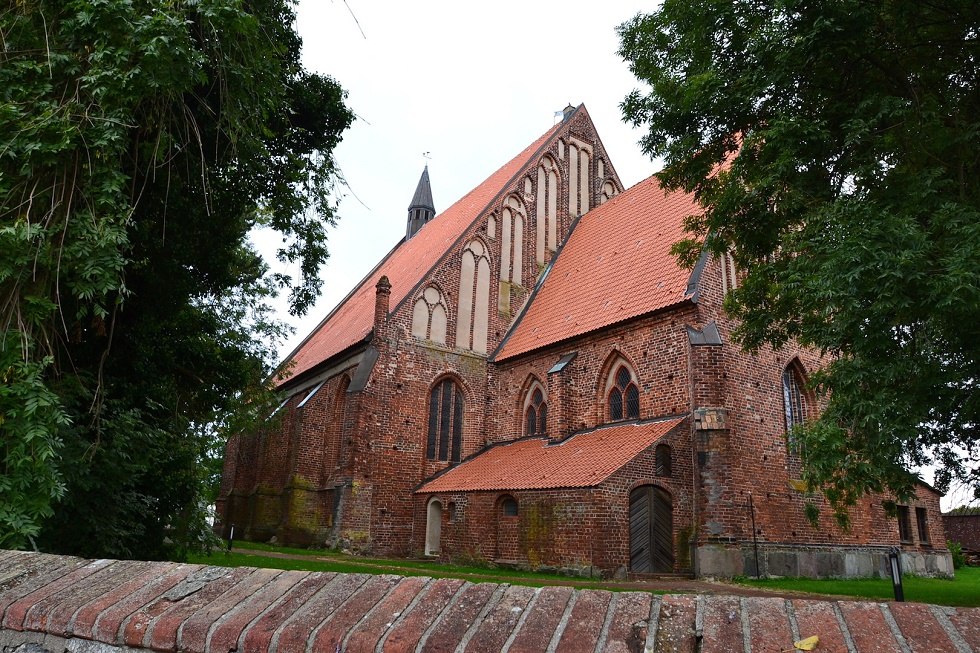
[259, 0, 658, 356]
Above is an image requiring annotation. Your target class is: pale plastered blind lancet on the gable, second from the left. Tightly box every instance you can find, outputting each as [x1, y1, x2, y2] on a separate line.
[456, 240, 490, 354]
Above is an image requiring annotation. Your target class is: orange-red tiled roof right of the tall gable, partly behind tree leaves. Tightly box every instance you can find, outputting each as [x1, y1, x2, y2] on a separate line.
[494, 177, 702, 361]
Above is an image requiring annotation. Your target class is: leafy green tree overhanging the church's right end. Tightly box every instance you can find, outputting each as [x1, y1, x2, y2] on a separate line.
[619, 0, 980, 520]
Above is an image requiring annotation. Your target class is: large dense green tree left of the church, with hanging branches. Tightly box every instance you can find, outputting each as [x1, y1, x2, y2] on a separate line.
[0, 0, 353, 557]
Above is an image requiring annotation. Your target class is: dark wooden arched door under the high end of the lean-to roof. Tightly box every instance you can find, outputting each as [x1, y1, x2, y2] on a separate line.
[630, 485, 674, 574]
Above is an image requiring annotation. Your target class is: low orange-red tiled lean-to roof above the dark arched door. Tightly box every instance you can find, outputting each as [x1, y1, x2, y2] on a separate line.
[416, 417, 683, 493]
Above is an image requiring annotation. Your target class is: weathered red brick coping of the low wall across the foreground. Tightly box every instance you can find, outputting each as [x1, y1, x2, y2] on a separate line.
[0, 551, 980, 653]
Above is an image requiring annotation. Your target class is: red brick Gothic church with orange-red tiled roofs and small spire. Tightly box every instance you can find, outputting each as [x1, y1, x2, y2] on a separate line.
[217, 106, 952, 576]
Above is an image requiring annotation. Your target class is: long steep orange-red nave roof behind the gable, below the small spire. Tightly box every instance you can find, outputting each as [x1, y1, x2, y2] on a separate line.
[286, 123, 562, 379]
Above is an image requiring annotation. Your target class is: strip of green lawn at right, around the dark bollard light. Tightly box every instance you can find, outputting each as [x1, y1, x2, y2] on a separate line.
[737, 567, 980, 607]
